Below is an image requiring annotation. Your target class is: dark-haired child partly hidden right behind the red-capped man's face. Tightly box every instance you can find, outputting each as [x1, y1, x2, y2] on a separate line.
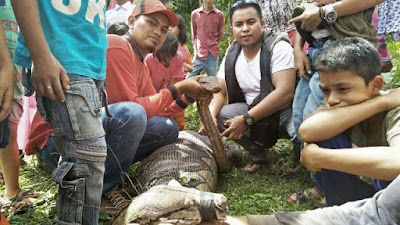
[170, 14, 193, 74]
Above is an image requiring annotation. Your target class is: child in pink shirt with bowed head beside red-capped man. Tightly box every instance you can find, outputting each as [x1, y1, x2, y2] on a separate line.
[145, 33, 185, 130]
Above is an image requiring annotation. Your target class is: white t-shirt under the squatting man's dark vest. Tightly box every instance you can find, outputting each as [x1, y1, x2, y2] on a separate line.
[217, 41, 294, 105]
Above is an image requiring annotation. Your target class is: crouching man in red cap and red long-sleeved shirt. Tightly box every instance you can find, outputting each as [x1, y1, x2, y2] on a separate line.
[106, 0, 216, 213]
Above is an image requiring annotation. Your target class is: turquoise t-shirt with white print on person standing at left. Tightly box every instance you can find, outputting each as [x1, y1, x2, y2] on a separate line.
[13, 0, 107, 80]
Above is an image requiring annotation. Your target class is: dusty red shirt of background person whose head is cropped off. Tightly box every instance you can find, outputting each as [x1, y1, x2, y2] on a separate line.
[191, 6, 225, 60]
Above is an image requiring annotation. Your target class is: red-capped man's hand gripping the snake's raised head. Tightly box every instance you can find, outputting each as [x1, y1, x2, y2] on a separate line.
[175, 76, 218, 101]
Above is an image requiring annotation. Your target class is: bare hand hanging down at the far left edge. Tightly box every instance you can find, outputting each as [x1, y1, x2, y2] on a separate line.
[0, 63, 15, 121]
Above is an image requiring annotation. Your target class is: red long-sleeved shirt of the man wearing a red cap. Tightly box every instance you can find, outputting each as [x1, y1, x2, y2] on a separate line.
[106, 35, 183, 118]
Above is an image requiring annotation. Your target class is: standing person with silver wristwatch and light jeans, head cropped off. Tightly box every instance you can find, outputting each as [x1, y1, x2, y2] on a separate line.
[289, 0, 378, 145]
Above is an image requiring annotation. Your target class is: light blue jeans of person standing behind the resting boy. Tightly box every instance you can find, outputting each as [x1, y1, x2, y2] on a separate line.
[293, 39, 332, 139]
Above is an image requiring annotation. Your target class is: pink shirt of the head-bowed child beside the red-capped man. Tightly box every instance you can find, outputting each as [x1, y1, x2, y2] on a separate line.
[144, 52, 185, 92]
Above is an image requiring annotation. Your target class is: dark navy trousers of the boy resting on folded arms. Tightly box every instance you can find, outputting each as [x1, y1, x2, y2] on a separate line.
[311, 133, 376, 206]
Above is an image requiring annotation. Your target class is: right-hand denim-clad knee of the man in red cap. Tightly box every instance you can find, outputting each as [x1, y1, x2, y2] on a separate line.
[134, 116, 179, 162]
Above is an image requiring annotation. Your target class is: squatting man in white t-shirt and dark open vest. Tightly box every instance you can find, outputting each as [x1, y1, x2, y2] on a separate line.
[200, 0, 296, 172]
